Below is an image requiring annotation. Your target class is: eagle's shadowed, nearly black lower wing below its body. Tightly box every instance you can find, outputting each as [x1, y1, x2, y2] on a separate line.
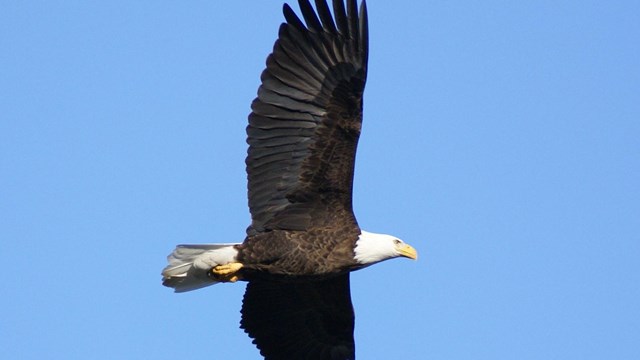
[240, 273, 355, 360]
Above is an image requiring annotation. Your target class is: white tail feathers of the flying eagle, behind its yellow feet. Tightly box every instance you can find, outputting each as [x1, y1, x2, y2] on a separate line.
[162, 244, 238, 292]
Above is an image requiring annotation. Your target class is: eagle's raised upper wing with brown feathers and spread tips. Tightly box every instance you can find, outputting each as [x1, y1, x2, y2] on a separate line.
[246, 0, 368, 235]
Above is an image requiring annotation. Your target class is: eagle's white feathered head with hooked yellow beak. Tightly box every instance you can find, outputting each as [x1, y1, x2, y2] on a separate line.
[354, 230, 418, 265]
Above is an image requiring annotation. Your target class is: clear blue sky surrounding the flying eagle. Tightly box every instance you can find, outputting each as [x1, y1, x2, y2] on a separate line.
[0, 0, 640, 360]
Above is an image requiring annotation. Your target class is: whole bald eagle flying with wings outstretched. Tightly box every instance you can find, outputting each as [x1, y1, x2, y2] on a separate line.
[162, 0, 417, 360]
